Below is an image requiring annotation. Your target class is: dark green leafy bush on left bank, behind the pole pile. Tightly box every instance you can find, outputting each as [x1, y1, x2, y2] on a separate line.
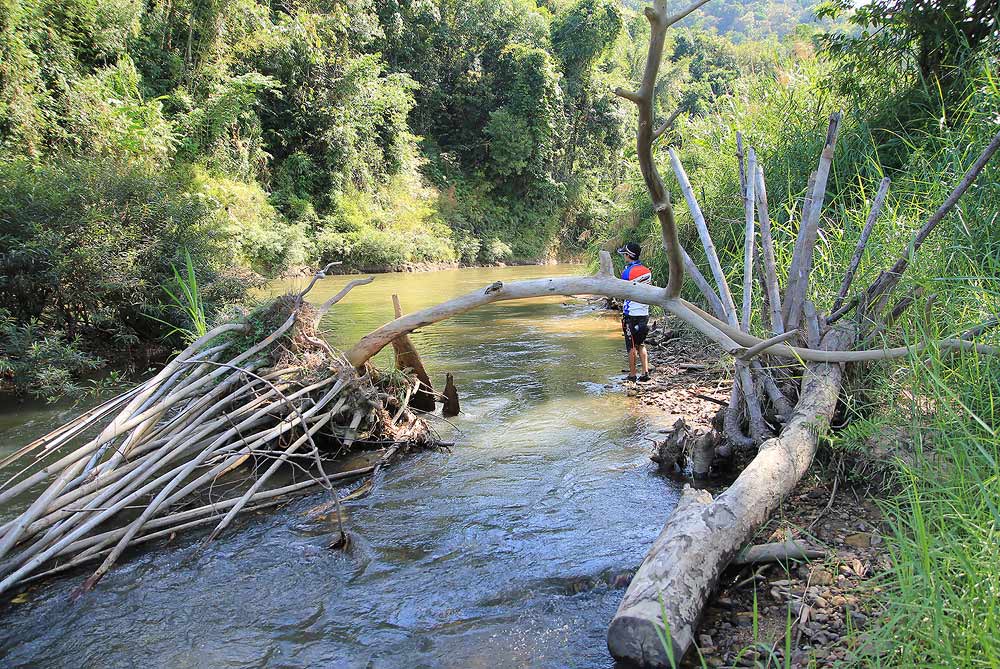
[0, 160, 266, 396]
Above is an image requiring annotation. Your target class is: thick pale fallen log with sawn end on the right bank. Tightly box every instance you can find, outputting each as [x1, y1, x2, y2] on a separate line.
[608, 326, 855, 667]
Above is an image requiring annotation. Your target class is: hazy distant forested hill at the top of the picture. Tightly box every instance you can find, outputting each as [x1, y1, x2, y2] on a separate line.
[622, 0, 819, 40]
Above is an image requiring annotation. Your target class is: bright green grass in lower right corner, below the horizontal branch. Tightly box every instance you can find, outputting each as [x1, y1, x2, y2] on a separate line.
[861, 348, 1000, 667]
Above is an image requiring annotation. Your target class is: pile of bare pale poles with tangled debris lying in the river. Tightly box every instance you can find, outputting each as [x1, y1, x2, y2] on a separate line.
[0, 272, 430, 593]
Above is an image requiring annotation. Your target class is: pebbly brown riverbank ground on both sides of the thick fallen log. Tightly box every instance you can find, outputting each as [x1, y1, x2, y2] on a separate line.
[629, 320, 891, 668]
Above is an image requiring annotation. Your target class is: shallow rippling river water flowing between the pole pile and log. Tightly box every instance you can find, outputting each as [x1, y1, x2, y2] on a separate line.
[0, 266, 679, 669]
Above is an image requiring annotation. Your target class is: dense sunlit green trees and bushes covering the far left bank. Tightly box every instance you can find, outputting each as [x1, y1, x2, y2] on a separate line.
[0, 0, 812, 395]
